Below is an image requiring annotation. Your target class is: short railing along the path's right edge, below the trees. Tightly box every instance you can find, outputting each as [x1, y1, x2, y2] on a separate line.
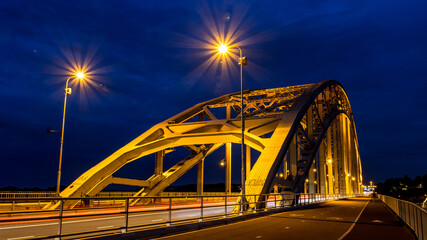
[378, 195, 427, 240]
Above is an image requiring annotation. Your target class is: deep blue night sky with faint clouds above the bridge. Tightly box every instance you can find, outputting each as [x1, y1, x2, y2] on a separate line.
[0, 0, 427, 188]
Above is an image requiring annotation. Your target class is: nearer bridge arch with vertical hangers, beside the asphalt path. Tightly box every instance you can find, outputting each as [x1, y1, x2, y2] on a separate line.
[246, 80, 363, 209]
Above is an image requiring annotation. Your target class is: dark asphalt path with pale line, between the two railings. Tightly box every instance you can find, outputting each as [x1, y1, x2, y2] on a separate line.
[152, 198, 415, 240]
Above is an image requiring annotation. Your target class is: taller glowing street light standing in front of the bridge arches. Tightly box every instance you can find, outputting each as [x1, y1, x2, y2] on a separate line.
[218, 44, 248, 208]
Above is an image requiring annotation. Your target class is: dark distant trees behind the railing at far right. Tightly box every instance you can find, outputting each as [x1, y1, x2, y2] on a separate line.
[377, 174, 427, 203]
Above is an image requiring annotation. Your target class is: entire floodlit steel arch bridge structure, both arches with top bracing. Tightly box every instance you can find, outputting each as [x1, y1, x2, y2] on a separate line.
[51, 80, 362, 210]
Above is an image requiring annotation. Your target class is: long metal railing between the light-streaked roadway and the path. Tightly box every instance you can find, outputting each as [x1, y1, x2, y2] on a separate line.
[0, 193, 343, 239]
